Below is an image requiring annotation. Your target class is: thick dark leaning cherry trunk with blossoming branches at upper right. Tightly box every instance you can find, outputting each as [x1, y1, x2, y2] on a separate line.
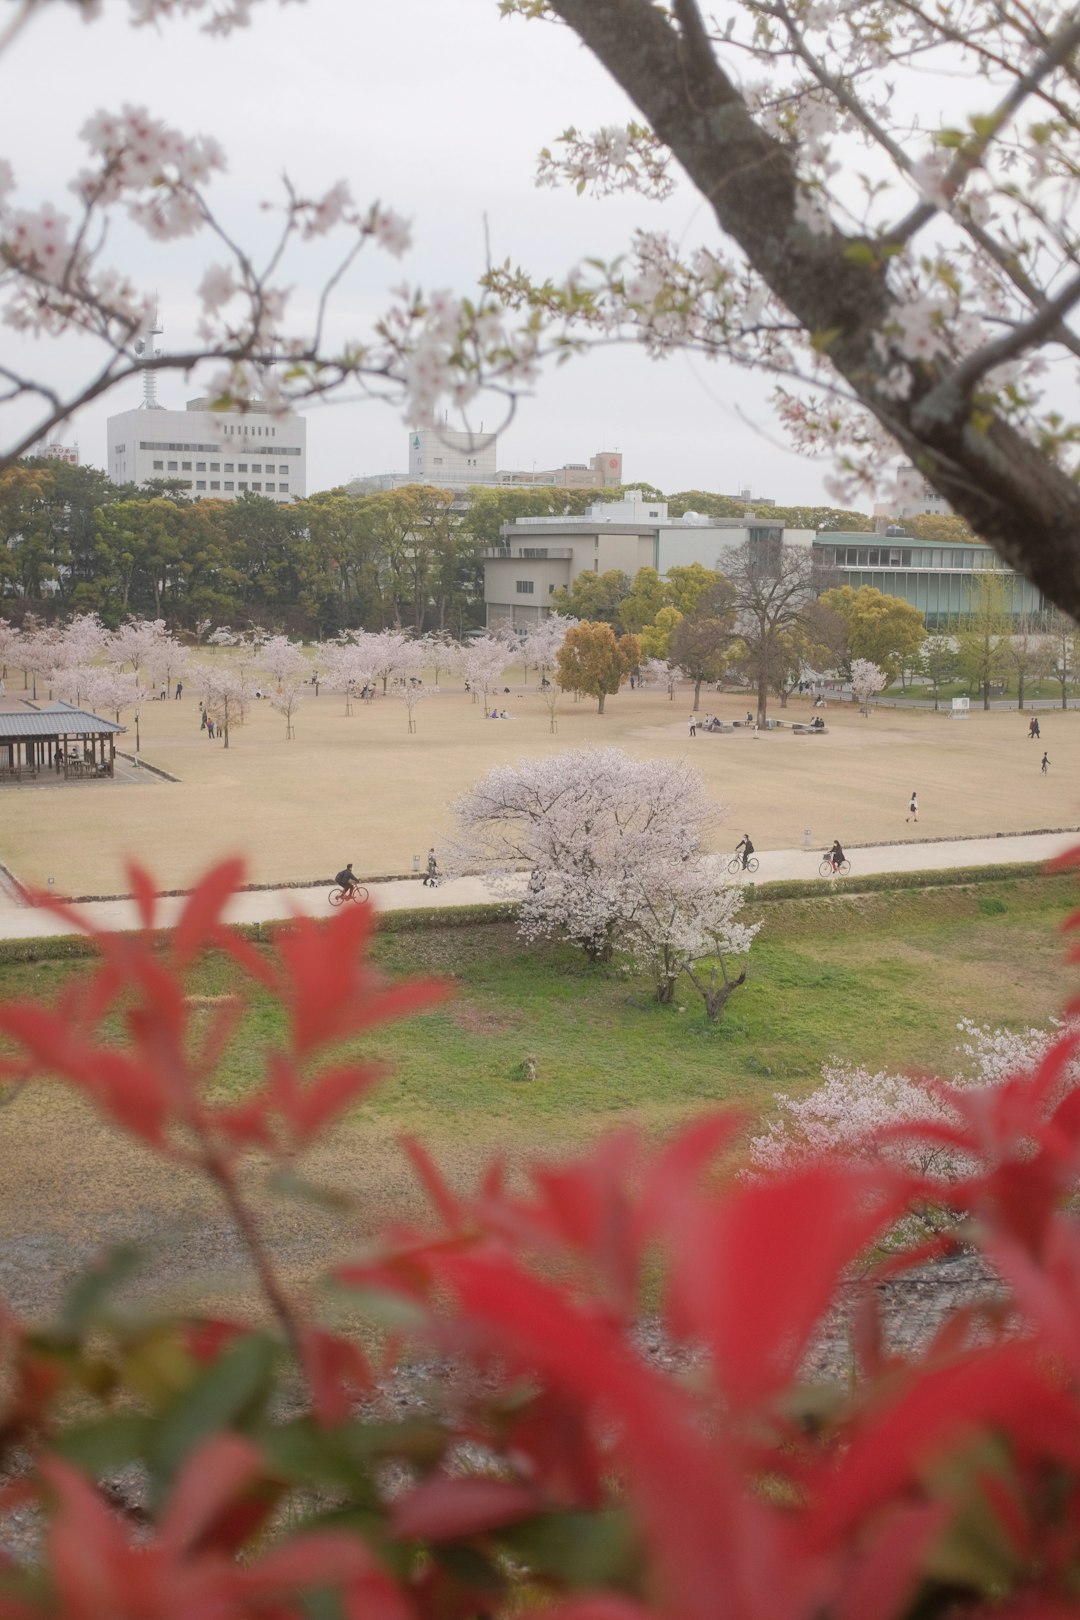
[489, 0, 1080, 617]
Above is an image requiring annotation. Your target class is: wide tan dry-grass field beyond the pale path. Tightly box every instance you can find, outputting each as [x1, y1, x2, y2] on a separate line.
[0, 657, 1080, 894]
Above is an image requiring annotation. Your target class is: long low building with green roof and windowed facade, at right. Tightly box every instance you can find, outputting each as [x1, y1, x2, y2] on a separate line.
[814, 527, 1051, 630]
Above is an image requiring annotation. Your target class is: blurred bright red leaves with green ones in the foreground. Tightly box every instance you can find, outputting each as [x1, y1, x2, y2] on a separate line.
[0, 863, 1080, 1620]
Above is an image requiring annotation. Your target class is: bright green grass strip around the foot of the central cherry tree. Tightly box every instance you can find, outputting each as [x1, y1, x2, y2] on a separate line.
[0, 878, 1075, 1147]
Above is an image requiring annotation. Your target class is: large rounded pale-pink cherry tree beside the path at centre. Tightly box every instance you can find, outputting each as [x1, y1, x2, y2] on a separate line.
[447, 748, 721, 961]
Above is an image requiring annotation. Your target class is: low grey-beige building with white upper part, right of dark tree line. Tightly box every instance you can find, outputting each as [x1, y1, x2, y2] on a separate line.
[484, 496, 814, 629]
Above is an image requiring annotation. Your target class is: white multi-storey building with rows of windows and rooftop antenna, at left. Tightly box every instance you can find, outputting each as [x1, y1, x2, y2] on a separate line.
[108, 399, 308, 501]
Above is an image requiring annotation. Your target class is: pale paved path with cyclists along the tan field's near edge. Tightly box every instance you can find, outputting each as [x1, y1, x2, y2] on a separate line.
[0, 829, 1080, 940]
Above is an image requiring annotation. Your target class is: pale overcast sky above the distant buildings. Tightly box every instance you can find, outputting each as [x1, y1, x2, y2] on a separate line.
[5, 0, 829, 502]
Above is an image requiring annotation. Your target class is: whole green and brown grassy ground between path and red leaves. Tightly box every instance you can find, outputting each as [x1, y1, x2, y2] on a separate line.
[0, 876, 1077, 1311]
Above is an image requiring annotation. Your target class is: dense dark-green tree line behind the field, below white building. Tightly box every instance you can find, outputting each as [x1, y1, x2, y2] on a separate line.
[0, 458, 906, 638]
